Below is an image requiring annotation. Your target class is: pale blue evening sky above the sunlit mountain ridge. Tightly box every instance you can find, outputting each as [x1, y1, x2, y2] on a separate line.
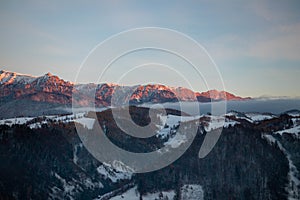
[0, 0, 300, 97]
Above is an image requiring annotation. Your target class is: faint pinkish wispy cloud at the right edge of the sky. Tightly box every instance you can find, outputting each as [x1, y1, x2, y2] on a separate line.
[209, 23, 300, 61]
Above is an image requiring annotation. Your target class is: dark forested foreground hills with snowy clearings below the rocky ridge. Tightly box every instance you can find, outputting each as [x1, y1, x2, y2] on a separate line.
[0, 106, 300, 200]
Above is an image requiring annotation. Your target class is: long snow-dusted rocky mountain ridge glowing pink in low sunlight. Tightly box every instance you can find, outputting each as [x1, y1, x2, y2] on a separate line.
[0, 70, 249, 116]
